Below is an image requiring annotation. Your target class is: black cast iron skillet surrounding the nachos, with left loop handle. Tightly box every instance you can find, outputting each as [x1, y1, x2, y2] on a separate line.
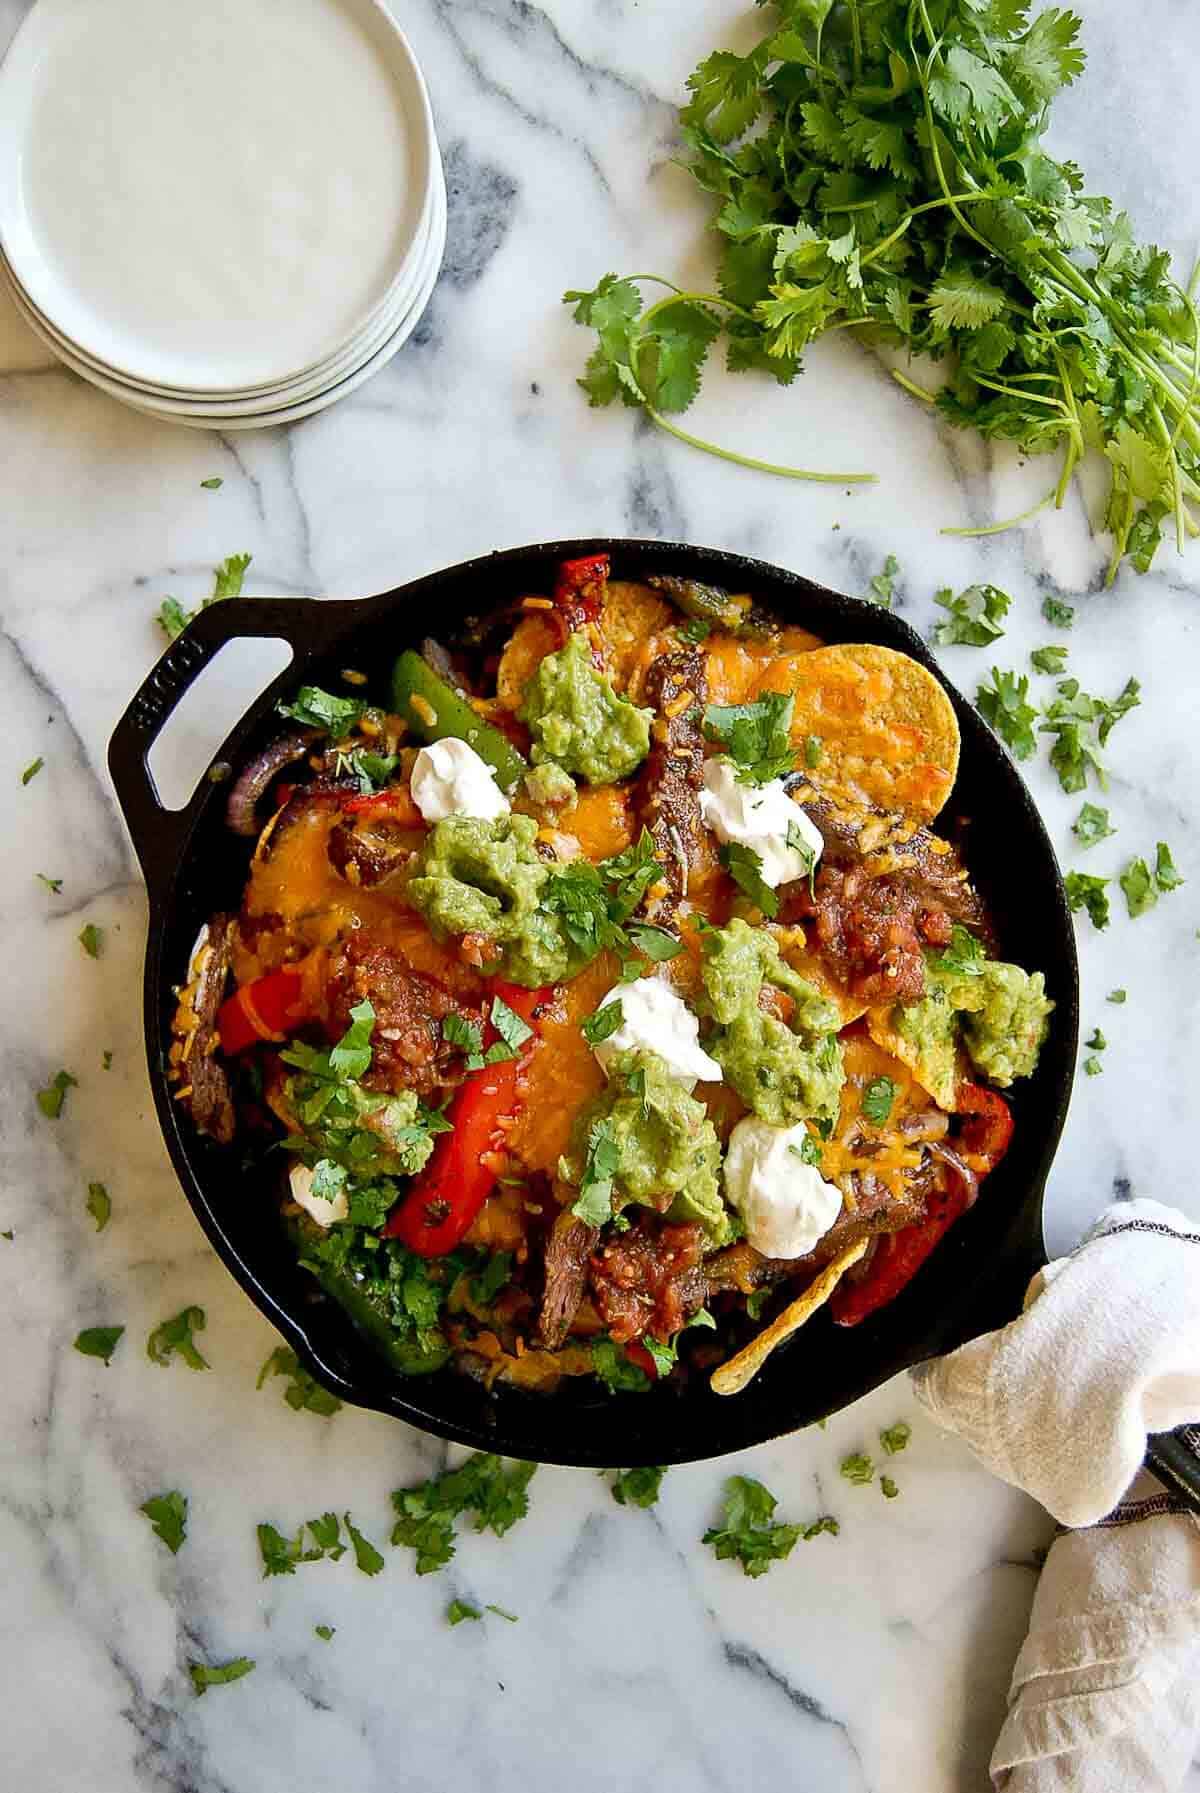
[109, 540, 1200, 1486]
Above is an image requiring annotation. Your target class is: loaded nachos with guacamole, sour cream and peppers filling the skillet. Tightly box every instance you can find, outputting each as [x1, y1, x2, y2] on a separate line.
[170, 556, 1053, 1393]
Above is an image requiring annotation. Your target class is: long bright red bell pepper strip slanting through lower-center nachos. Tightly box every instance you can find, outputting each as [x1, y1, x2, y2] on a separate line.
[384, 979, 551, 1257]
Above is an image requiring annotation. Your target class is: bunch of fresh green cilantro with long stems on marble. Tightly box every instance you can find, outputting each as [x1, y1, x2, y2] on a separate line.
[565, 0, 1200, 579]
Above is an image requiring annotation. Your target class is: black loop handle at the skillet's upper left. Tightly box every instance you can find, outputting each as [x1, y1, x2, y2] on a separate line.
[108, 597, 321, 895]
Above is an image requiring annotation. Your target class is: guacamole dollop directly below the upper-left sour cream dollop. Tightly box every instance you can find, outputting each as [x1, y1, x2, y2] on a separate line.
[407, 816, 588, 990]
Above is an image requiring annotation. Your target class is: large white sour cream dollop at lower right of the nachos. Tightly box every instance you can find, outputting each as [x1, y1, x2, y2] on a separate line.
[725, 1115, 841, 1257]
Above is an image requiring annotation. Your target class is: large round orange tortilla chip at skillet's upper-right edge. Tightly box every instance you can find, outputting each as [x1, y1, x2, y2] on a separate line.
[761, 644, 960, 821]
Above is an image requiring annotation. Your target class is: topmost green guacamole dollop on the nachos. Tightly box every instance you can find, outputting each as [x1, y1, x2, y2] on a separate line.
[517, 635, 651, 784]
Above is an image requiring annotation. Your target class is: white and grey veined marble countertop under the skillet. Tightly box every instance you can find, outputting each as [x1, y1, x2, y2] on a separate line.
[0, 0, 1200, 1793]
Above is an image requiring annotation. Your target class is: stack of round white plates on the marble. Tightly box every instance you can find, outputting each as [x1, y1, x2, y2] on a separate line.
[0, 0, 447, 430]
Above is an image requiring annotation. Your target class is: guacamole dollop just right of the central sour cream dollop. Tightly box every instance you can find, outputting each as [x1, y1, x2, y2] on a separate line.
[701, 918, 845, 1126]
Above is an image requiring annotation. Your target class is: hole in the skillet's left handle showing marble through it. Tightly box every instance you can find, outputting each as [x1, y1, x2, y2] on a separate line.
[147, 635, 292, 809]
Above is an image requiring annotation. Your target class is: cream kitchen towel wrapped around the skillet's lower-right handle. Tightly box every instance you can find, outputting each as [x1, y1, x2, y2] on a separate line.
[913, 1201, 1200, 1793]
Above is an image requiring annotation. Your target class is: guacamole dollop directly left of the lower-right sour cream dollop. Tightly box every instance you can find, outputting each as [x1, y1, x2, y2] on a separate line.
[558, 1052, 734, 1248]
